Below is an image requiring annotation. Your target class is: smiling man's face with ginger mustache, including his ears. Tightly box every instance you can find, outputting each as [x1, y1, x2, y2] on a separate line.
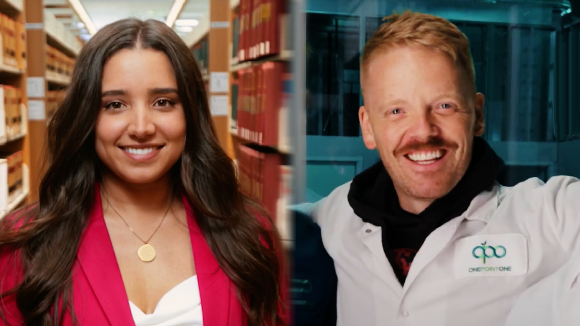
[359, 46, 484, 213]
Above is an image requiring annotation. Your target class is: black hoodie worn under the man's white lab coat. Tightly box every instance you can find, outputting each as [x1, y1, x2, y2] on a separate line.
[348, 137, 504, 285]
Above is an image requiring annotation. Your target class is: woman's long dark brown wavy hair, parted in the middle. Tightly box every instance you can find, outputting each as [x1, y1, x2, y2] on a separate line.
[0, 19, 284, 326]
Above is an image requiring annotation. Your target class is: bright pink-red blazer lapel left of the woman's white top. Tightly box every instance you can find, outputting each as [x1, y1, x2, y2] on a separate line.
[75, 185, 135, 325]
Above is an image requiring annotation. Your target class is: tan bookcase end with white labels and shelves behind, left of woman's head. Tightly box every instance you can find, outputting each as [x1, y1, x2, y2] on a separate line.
[24, 0, 83, 201]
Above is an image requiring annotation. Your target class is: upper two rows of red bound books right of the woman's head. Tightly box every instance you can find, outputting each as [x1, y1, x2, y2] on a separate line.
[229, 0, 293, 154]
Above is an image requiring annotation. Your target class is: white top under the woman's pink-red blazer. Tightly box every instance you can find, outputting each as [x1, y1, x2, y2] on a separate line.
[129, 275, 203, 326]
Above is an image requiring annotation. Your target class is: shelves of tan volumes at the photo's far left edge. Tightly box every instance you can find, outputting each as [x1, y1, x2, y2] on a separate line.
[0, 0, 29, 218]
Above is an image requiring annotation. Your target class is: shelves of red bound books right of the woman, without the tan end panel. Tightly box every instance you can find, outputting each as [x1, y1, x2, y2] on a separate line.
[228, 0, 292, 246]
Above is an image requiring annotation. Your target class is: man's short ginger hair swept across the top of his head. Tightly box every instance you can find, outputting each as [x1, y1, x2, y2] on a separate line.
[360, 10, 476, 92]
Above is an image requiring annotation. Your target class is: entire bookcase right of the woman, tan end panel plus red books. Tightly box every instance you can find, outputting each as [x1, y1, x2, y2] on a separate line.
[184, 0, 292, 245]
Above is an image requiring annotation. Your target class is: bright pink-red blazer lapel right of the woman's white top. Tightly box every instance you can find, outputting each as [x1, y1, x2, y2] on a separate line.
[182, 196, 234, 326]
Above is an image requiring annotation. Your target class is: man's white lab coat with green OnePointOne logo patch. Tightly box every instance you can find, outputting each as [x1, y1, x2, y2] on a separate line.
[312, 177, 580, 326]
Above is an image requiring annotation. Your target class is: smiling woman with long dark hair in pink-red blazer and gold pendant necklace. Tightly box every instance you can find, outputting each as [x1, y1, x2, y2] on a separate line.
[0, 19, 285, 326]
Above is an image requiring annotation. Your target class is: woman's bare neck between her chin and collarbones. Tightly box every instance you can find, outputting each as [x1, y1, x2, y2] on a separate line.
[100, 171, 172, 221]
